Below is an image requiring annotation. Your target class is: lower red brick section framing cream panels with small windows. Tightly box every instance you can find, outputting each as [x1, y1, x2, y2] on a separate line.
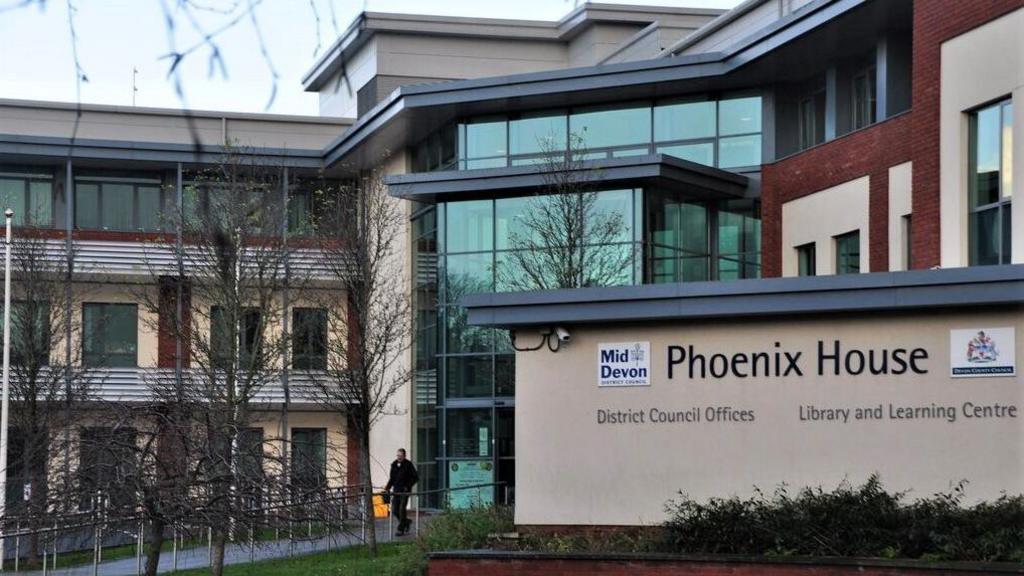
[761, 114, 916, 277]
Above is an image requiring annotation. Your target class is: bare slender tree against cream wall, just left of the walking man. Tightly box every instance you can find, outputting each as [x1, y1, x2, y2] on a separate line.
[303, 168, 412, 556]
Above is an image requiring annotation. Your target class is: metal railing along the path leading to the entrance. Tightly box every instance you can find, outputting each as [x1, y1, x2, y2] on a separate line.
[0, 482, 510, 575]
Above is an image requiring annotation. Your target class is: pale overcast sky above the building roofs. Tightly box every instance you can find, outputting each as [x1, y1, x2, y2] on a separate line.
[0, 0, 740, 115]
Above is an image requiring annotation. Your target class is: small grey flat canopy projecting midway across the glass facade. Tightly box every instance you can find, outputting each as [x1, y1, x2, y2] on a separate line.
[386, 154, 749, 203]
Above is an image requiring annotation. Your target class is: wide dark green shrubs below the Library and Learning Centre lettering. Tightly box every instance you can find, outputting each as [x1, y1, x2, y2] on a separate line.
[664, 476, 1024, 562]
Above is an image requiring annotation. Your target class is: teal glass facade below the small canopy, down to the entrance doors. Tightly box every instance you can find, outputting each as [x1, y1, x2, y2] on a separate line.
[413, 186, 761, 505]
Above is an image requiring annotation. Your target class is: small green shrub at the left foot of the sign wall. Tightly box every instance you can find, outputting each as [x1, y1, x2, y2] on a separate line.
[388, 506, 515, 576]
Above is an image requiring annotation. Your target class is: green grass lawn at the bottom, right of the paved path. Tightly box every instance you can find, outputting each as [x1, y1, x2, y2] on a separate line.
[175, 542, 412, 576]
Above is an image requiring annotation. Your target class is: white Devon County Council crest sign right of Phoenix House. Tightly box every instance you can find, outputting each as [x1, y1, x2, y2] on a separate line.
[949, 328, 1017, 377]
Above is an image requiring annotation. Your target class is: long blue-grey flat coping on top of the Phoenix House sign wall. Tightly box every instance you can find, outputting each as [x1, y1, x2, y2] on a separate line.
[460, 264, 1024, 329]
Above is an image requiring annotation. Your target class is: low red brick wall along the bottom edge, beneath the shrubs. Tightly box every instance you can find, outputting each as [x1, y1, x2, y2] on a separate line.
[428, 554, 1024, 576]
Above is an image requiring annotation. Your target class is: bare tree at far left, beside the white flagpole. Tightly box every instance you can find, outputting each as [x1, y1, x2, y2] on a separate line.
[8, 227, 90, 559]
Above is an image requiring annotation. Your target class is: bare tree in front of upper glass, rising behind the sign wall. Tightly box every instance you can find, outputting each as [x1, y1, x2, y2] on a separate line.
[496, 135, 634, 291]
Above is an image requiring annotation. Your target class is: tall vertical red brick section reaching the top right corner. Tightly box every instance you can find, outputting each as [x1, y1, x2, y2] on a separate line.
[910, 0, 1024, 269]
